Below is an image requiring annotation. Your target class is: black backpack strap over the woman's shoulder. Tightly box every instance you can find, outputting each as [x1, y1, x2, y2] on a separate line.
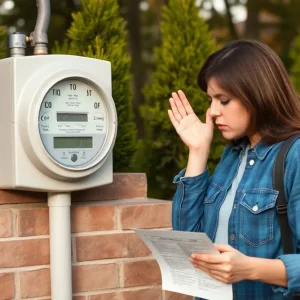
[273, 134, 300, 254]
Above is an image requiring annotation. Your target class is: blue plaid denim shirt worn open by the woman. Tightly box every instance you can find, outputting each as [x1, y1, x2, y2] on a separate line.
[172, 139, 300, 300]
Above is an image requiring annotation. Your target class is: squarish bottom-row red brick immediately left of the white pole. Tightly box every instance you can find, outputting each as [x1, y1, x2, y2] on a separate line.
[20, 269, 51, 298]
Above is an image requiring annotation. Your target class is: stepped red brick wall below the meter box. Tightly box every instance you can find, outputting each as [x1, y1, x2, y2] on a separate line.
[0, 174, 192, 300]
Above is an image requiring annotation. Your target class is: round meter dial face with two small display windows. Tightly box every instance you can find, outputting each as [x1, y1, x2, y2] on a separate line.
[39, 79, 108, 169]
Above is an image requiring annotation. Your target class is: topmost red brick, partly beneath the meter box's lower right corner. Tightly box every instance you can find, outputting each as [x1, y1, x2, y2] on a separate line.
[72, 173, 147, 201]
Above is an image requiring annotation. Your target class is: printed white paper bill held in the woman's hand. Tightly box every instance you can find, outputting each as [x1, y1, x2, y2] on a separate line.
[133, 229, 232, 300]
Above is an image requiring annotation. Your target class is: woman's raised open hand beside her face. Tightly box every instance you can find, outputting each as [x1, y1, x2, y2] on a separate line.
[168, 91, 214, 151]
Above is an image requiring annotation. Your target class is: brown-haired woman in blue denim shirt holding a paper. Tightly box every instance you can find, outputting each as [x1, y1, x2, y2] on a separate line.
[168, 41, 300, 300]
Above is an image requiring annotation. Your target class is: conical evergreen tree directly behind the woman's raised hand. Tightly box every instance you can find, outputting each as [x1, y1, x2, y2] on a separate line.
[137, 0, 224, 199]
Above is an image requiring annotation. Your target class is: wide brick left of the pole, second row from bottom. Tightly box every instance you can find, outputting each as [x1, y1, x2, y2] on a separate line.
[0, 239, 50, 268]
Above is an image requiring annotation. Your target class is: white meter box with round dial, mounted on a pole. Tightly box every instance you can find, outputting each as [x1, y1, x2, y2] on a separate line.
[0, 55, 117, 191]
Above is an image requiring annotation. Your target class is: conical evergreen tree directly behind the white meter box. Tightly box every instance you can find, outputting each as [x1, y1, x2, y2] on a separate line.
[52, 0, 136, 171]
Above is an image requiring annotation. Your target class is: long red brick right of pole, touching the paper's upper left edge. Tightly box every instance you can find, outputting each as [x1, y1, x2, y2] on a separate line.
[76, 233, 151, 261]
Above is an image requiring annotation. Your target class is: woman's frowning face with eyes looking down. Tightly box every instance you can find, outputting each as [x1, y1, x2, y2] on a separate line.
[207, 78, 260, 146]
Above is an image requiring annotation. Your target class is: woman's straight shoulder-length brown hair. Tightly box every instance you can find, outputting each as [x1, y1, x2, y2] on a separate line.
[198, 40, 300, 144]
